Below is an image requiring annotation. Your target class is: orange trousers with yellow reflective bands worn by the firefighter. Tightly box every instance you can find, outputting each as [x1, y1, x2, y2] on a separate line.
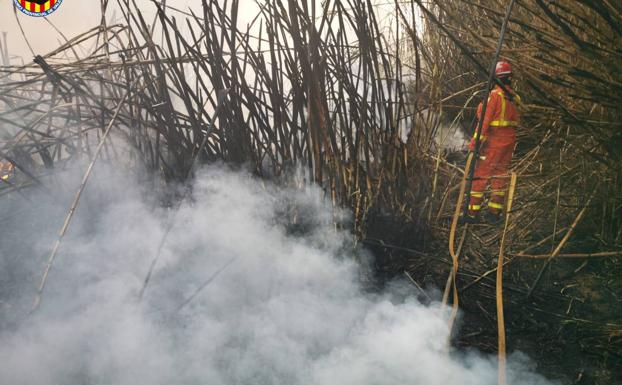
[469, 127, 516, 216]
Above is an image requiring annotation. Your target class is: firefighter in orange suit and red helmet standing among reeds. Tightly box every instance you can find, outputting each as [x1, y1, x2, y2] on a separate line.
[464, 61, 520, 223]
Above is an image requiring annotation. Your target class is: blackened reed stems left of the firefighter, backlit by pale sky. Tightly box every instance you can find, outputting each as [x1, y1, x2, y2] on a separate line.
[2, 1, 438, 238]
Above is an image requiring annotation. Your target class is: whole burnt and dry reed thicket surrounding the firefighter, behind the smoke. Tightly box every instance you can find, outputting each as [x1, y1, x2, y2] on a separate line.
[0, 0, 622, 384]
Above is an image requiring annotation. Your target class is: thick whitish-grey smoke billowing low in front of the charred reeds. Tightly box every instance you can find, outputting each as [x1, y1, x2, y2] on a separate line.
[0, 165, 548, 385]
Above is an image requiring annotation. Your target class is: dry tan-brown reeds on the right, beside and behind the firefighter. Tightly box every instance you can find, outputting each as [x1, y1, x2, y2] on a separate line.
[410, 0, 622, 383]
